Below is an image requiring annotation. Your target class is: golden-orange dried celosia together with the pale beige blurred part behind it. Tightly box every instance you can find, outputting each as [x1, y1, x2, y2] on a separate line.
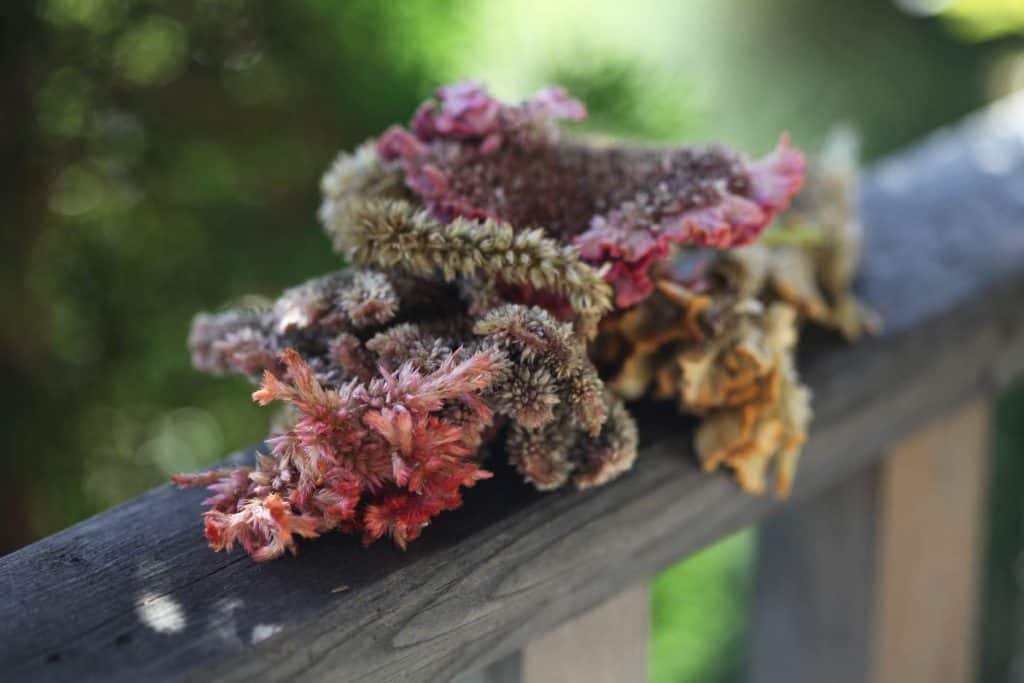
[592, 133, 878, 495]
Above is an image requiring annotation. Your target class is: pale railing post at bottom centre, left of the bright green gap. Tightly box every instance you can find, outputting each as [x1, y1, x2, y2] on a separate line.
[457, 585, 650, 683]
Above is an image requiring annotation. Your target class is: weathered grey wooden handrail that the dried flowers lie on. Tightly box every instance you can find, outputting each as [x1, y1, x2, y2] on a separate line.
[6, 93, 1024, 682]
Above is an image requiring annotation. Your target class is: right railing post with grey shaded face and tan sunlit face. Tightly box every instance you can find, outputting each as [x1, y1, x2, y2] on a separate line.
[749, 398, 990, 683]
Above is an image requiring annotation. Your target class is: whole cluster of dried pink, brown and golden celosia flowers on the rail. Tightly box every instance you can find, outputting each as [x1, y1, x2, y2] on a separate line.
[175, 84, 873, 560]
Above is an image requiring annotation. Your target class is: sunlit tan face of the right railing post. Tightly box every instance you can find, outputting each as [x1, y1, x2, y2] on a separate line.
[871, 399, 990, 683]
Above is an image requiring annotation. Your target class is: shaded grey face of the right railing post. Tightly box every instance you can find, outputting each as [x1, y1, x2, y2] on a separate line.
[746, 465, 882, 683]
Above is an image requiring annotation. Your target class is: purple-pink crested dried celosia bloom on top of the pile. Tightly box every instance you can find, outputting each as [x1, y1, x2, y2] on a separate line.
[368, 83, 804, 306]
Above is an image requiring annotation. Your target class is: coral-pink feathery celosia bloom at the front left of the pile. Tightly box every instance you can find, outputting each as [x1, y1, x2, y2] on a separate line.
[174, 349, 500, 560]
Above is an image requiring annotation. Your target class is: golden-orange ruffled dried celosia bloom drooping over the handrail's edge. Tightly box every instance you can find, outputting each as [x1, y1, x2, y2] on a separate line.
[598, 282, 811, 495]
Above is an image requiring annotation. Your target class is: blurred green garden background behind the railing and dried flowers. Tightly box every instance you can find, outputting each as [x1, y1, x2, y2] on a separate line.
[6, 0, 1024, 681]
